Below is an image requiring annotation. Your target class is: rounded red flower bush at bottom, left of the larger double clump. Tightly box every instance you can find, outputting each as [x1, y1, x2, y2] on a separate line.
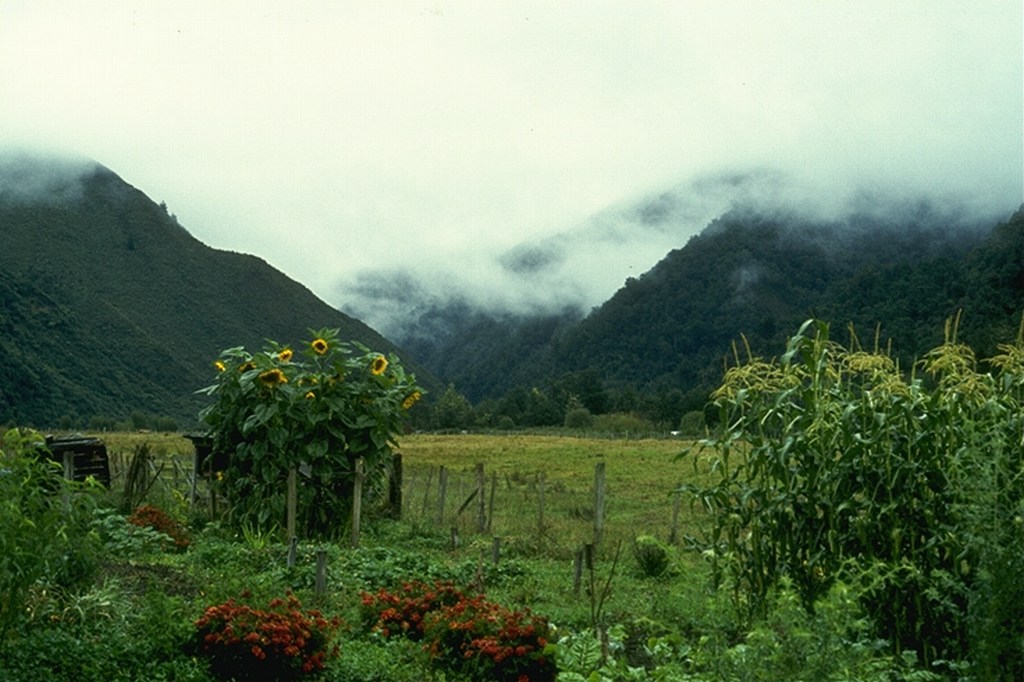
[194, 593, 341, 680]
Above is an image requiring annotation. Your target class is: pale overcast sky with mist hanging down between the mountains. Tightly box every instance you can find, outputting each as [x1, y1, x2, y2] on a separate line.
[0, 0, 1024, 331]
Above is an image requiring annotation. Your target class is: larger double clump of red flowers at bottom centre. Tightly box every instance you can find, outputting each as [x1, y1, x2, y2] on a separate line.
[362, 583, 558, 682]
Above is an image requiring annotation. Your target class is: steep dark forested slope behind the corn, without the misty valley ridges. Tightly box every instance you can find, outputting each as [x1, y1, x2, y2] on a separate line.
[556, 205, 995, 387]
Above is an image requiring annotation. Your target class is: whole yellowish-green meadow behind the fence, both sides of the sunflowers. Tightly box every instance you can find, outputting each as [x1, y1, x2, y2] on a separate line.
[94, 433, 693, 557]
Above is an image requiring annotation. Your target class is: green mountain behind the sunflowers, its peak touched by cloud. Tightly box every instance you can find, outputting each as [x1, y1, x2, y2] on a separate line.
[0, 159, 426, 426]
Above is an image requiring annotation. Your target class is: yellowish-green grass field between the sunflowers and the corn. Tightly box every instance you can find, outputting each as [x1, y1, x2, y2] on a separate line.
[399, 434, 691, 555]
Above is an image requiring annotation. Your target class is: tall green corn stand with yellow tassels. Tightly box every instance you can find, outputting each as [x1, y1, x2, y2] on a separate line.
[684, 321, 1024, 670]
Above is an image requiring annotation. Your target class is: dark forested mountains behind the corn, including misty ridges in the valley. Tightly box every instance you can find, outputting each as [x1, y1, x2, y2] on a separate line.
[403, 204, 1024, 423]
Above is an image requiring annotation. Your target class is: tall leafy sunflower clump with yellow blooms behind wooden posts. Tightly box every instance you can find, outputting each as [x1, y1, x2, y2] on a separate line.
[200, 329, 423, 537]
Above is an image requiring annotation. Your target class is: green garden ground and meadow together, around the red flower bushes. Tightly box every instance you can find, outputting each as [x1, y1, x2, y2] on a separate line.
[0, 433, 932, 682]
